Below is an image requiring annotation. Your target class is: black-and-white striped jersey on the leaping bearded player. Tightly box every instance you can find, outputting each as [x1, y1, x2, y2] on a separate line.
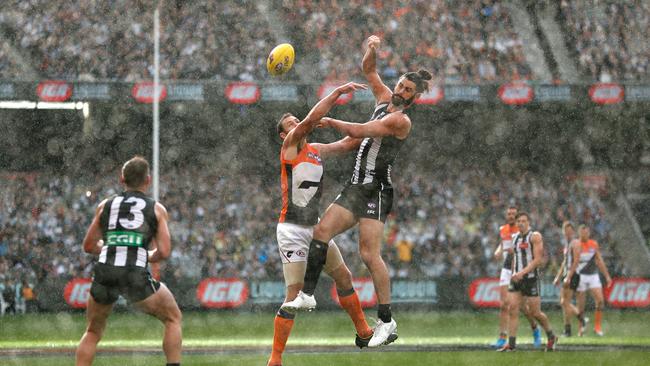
[350, 103, 404, 187]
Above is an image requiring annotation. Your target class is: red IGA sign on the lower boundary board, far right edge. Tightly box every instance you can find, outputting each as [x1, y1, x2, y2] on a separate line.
[605, 278, 650, 308]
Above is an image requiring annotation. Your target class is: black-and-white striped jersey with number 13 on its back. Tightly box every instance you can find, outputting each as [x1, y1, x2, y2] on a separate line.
[99, 191, 158, 267]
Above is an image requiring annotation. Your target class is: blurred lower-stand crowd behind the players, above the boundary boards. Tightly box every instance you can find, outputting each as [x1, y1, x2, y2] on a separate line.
[0, 167, 622, 310]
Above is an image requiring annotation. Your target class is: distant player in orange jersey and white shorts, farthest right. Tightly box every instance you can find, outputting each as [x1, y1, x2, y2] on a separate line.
[567, 225, 612, 336]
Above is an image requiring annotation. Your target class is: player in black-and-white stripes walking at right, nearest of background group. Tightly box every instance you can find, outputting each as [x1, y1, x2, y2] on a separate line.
[499, 212, 557, 352]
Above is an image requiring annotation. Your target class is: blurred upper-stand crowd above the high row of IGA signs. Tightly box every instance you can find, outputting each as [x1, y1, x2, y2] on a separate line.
[0, 0, 650, 83]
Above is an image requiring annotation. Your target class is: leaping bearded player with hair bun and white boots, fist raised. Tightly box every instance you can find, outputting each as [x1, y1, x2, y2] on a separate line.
[282, 36, 431, 347]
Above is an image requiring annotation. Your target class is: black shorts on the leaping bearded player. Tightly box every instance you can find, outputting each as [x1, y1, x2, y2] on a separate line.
[334, 183, 393, 222]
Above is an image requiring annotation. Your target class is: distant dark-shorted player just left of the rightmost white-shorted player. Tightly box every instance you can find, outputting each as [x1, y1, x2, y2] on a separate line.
[553, 221, 584, 337]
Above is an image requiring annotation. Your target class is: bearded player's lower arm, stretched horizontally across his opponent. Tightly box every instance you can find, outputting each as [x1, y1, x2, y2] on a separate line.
[321, 113, 411, 139]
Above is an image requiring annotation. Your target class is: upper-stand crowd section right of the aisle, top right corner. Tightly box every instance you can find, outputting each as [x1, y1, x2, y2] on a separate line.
[560, 0, 650, 82]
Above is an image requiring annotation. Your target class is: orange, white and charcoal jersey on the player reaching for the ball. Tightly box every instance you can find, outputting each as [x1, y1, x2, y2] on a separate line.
[279, 144, 323, 226]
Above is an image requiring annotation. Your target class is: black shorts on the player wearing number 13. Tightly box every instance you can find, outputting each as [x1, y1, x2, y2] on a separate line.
[90, 263, 160, 305]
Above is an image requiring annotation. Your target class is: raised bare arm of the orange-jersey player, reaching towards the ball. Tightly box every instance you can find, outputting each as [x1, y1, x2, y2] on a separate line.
[282, 82, 368, 147]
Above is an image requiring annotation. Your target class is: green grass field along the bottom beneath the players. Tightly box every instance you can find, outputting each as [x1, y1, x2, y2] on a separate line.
[0, 311, 650, 366]
